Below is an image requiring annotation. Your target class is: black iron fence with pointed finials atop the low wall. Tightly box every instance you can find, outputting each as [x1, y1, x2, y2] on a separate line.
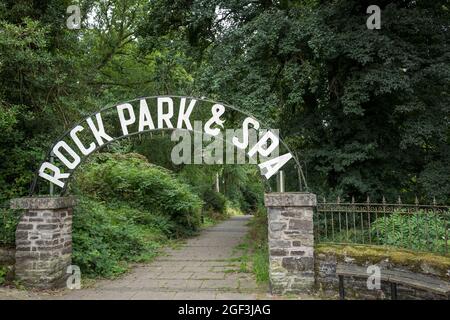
[314, 198, 450, 254]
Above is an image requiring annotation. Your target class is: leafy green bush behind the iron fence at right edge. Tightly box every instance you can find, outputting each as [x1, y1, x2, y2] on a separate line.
[371, 210, 446, 252]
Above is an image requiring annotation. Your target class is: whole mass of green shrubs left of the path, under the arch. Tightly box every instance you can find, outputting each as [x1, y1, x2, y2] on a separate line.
[72, 153, 206, 277]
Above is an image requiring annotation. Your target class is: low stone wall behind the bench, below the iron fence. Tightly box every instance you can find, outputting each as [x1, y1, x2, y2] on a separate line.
[315, 247, 450, 300]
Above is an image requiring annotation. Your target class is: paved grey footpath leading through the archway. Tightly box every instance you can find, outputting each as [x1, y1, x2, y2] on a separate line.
[0, 216, 270, 300]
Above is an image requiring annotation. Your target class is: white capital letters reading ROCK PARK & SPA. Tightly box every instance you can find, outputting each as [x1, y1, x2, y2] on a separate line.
[38, 96, 292, 188]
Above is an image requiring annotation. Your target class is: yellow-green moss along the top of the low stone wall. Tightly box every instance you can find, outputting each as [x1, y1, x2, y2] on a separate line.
[315, 244, 450, 279]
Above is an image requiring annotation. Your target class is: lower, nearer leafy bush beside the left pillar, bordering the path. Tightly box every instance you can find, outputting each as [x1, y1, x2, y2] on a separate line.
[73, 198, 170, 277]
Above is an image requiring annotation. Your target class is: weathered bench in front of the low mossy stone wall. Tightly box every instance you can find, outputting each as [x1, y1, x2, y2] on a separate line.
[336, 263, 450, 300]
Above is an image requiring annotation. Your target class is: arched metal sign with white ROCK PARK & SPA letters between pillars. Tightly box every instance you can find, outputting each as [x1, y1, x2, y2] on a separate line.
[30, 96, 306, 195]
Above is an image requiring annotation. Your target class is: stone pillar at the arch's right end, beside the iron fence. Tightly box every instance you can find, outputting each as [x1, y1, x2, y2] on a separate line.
[265, 192, 317, 294]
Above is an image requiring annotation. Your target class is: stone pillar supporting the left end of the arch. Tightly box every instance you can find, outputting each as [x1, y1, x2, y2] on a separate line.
[11, 197, 75, 289]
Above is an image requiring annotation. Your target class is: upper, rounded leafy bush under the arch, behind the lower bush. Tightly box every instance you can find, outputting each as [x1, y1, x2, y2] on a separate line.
[77, 153, 202, 236]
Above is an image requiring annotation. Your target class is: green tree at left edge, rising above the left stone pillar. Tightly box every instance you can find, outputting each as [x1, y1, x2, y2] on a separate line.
[0, 1, 93, 201]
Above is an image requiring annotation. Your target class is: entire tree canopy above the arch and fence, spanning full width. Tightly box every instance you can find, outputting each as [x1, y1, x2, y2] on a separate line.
[0, 0, 450, 202]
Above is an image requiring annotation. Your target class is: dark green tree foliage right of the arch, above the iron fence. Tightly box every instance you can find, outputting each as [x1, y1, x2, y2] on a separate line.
[139, 0, 450, 202]
